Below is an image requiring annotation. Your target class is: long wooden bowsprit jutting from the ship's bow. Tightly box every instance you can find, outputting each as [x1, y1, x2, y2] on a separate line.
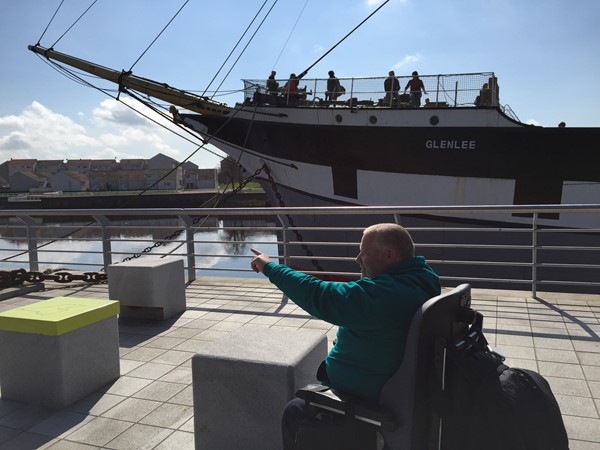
[28, 45, 231, 116]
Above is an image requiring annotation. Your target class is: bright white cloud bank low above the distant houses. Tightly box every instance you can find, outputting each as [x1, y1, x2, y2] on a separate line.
[0, 99, 188, 162]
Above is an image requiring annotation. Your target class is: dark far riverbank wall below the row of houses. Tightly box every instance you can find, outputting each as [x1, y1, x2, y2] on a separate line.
[0, 189, 269, 209]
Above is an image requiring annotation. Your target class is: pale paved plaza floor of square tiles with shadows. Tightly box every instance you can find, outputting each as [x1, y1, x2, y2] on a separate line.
[0, 277, 600, 450]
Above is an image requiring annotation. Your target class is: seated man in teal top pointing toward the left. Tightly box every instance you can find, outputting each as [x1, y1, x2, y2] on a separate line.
[251, 224, 440, 450]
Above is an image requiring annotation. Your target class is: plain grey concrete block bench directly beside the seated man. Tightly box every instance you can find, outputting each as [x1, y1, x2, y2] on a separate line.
[192, 326, 327, 450]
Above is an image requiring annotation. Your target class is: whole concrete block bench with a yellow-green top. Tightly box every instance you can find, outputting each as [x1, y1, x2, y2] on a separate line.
[0, 297, 120, 408]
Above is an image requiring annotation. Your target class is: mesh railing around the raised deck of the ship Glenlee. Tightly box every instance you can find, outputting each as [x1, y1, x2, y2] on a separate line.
[243, 72, 499, 108]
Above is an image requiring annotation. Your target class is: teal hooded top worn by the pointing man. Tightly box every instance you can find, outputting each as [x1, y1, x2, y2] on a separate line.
[263, 256, 441, 401]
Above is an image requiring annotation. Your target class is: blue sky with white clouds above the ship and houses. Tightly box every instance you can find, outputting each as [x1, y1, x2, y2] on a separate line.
[0, 0, 600, 168]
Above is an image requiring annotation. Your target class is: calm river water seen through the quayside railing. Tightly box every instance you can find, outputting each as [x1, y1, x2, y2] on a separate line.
[0, 218, 277, 277]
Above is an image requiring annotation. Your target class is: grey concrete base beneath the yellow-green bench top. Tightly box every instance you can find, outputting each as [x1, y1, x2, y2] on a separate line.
[0, 316, 120, 408]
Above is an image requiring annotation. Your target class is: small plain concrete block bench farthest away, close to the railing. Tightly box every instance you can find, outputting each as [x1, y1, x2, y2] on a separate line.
[107, 257, 185, 320]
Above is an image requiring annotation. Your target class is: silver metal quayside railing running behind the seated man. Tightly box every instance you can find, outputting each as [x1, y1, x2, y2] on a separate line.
[0, 205, 600, 295]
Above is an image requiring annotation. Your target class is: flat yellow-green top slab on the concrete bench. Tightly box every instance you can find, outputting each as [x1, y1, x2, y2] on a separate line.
[0, 297, 119, 336]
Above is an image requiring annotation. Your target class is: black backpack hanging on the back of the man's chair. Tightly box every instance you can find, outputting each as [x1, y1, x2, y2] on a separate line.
[441, 310, 569, 450]
